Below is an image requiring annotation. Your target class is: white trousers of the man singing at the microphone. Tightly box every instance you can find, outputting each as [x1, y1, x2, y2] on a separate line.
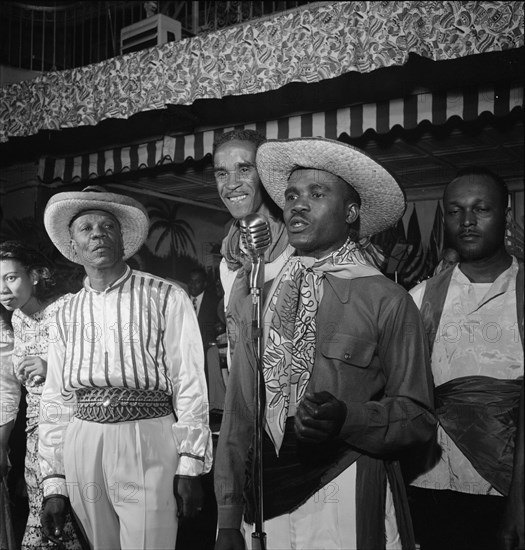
[243, 462, 401, 550]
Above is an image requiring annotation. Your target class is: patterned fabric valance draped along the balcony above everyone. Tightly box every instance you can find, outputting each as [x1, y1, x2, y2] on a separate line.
[0, 1, 524, 141]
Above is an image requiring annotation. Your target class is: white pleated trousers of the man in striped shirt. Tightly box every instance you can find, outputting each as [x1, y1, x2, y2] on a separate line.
[64, 415, 178, 550]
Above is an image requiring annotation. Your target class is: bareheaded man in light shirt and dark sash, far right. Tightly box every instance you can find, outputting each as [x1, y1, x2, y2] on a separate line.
[410, 166, 525, 550]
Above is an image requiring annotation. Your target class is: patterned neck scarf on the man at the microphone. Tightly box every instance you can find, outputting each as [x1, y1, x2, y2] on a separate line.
[263, 240, 381, 454]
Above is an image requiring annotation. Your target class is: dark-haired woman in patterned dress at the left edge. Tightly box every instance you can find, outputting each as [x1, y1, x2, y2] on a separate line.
[0, 241, 81, 550]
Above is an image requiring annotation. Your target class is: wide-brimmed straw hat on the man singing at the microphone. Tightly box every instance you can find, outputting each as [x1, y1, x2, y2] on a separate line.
[256, 138, 406, 238]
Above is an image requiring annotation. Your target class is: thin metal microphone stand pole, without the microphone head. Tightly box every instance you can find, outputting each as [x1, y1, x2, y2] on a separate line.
[250, 255, 266, 550]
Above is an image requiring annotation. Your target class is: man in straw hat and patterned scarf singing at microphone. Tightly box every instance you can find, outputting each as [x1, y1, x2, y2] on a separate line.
[215, 138, 436, 550]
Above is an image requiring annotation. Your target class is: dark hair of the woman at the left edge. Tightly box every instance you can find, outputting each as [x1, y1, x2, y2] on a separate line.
[0, 241, 62, 303]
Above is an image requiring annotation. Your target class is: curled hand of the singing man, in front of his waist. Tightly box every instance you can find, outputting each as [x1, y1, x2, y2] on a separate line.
[295, 391, 346, 443]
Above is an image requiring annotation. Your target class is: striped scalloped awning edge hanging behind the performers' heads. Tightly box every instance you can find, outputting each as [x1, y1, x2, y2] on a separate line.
[38, 83, 523, 183]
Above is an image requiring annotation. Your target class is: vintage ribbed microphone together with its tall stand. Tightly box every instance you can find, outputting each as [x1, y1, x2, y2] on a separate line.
[240, 214, 272, 550]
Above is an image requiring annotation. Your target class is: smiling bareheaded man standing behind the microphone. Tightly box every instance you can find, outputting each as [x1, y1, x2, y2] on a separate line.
[213, 130, 292, 364]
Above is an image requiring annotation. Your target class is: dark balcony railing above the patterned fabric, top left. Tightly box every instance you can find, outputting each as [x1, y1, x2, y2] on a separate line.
[0, 0, 311, 72]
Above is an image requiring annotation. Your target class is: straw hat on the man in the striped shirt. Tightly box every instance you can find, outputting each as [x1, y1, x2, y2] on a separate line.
[44, 186, 149, 263]
